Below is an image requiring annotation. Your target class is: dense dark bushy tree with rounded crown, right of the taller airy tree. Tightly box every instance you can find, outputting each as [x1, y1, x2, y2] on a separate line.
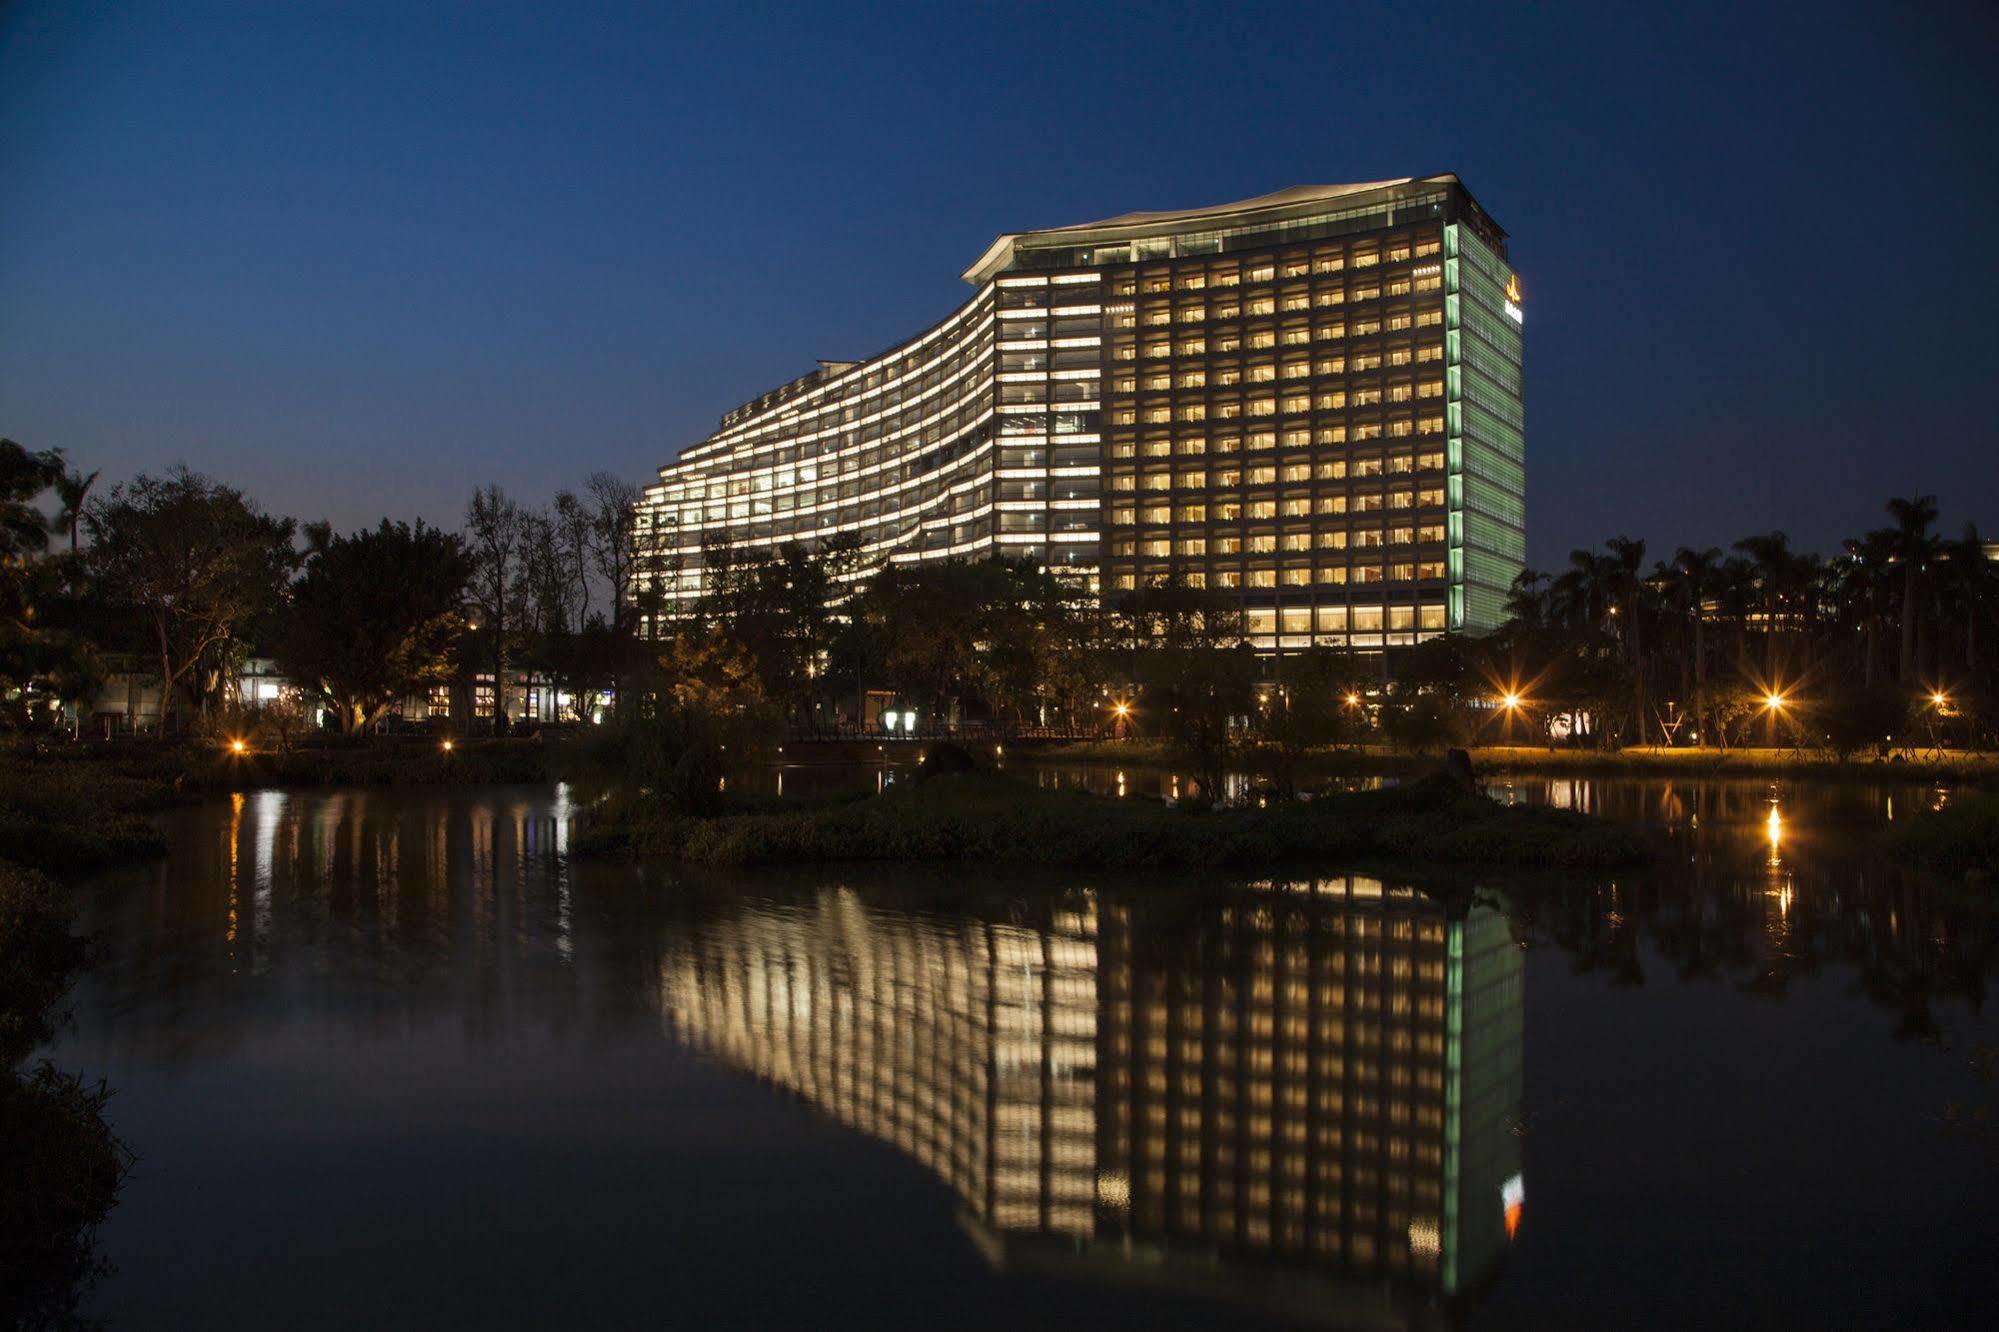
[278, 518, 472, 734]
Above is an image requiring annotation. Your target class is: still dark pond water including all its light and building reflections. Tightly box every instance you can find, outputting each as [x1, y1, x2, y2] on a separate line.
[42, 770, 1999, 1328]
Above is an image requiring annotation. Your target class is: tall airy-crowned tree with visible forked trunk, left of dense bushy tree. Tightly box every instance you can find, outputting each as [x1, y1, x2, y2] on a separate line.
[84, 466, 298, 732]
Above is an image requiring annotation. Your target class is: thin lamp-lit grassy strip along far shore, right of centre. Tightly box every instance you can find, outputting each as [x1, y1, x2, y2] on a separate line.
[1033, 740, 1999, 782]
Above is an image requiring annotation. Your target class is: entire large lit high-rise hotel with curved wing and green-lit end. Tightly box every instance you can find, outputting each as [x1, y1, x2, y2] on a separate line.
[640, 176, 1525, 650]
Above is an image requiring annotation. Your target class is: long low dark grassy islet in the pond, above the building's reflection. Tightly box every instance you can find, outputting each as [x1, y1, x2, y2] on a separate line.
[584, 772, 1649, 868]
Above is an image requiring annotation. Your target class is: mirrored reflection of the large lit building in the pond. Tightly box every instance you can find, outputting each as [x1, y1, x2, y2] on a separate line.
[662, 876, 1525, 1324]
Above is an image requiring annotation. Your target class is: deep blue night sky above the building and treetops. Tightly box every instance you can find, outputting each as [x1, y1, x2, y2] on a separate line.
[0, 0, 1999, 566]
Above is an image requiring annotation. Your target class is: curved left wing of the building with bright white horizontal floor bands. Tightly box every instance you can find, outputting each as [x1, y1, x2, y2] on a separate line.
[640, 274, 1101, 628]
